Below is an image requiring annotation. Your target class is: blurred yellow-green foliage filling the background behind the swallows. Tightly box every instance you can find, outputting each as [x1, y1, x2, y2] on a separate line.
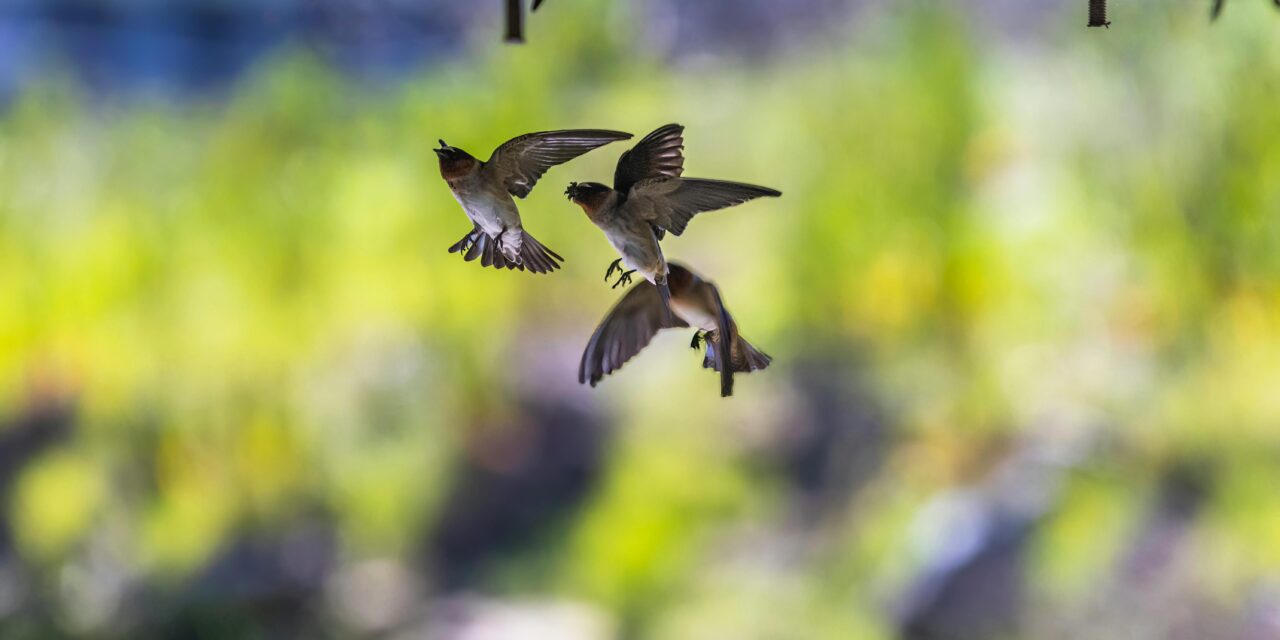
[0, 3, 1280, 639]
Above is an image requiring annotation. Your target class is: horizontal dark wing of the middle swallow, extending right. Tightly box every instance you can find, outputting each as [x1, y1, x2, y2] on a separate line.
[627, 178, 782, 236]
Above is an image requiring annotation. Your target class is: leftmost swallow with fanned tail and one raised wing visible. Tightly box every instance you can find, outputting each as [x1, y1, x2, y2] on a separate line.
[435, 129, 631, 274]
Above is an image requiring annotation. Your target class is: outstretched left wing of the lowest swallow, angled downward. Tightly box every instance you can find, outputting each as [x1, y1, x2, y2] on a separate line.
[577, 282, 689, 387]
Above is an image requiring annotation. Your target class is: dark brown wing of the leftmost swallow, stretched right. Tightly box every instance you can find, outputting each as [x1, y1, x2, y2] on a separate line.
[485, 129, 631, 197]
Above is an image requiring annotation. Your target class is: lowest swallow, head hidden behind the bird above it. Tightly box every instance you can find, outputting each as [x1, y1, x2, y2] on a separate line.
[577, 262, 773, 398]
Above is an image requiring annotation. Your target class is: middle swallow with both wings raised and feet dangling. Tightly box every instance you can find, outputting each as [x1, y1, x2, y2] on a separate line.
[564, 124, 782, 315]
